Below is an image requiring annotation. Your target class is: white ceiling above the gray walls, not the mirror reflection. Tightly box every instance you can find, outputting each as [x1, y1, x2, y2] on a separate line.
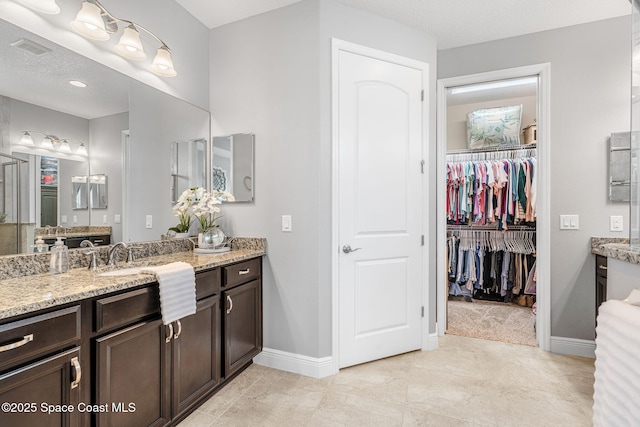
[176, 0, 631, 49]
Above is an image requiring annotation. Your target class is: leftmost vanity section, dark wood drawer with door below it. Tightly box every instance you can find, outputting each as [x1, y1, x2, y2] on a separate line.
[0, 305, 84, 427]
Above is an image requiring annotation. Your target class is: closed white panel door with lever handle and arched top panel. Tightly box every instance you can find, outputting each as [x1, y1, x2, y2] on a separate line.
[334, 44, 425, 368]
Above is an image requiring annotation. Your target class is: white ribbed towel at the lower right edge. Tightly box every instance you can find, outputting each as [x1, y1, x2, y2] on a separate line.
[593, 300, 640, 427]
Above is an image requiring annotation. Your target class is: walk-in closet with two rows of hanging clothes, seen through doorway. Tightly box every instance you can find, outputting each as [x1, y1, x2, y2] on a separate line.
[441, 77, 538, 346]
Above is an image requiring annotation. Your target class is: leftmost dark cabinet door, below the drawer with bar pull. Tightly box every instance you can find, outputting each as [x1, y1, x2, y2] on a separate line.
[0, 347, 82, 427]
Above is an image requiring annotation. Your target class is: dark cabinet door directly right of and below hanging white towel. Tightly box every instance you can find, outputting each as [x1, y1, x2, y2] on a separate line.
[172, 295, 221, 418]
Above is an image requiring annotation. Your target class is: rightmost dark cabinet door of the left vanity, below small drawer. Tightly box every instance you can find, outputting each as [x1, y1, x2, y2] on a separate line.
[223, 280, 262, 377]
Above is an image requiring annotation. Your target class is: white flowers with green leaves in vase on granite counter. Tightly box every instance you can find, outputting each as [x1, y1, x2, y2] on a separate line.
[170, 187, 235, 233]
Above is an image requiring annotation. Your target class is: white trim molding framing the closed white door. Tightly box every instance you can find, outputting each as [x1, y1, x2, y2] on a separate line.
[331, 38, 434, 373]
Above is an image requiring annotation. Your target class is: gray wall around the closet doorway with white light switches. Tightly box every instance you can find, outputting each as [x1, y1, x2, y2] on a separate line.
[438, 17, 631, 340]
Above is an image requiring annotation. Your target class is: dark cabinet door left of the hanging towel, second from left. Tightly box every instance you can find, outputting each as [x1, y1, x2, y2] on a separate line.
[95, 320, 171, 427]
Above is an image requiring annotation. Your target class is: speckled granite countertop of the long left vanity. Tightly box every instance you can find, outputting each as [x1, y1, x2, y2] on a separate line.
[0, 238, 266, 320]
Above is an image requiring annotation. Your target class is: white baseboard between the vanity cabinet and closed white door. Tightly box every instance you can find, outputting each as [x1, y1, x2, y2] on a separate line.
[253, 348, 338, 378]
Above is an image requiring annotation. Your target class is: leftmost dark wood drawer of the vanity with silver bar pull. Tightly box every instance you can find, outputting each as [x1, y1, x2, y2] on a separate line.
[0, 305, 81, 368]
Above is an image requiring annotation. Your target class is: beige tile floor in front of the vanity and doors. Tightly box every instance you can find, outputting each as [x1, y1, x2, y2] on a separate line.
[179, 335, 594, 427]
